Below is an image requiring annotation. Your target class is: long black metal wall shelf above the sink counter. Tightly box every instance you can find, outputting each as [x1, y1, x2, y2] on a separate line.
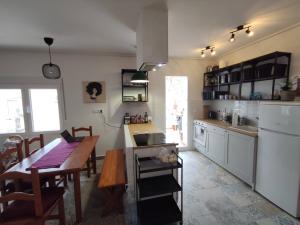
[203, 51, 291, 100]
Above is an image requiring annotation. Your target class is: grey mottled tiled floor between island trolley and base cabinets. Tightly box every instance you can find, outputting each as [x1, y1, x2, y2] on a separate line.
[181, 151, 300, 225]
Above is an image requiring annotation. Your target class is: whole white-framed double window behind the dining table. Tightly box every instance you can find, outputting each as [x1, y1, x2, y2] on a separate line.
[0, 84, 61, 135]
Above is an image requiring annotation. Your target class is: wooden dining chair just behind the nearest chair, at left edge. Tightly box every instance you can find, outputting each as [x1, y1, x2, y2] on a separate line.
[0, 143, 23, 196]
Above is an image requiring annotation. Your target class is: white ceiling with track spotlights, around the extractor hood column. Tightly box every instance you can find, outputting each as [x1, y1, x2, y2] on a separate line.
[0, 0, 300, 57]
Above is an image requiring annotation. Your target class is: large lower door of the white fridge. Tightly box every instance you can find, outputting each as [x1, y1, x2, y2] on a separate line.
[256, 129, 300, 216]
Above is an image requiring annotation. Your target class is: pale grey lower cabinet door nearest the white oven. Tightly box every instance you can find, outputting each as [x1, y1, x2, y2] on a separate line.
[207, 130, 226, 165]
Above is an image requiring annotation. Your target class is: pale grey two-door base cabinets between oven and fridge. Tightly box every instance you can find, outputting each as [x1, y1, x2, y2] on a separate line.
[194, 122, 257, 188]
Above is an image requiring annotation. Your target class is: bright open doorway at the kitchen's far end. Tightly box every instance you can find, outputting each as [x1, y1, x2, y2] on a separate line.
[165, 76, 188, 148]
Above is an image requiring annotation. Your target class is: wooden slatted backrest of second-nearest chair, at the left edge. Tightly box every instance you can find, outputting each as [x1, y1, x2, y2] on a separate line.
[0, 143, 23, 174]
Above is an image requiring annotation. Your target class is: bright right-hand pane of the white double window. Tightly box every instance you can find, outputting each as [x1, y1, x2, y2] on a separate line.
[29, 89, 60, 132]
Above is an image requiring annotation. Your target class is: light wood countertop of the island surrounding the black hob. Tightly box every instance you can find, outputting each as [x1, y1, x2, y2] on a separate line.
[124, 123, 177, 149]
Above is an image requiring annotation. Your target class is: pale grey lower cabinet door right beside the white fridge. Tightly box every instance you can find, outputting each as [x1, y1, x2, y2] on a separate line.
[226, 131, 256, 185]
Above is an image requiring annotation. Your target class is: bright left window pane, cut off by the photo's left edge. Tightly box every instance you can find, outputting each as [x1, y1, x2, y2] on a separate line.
[0, 89, 25, 134]
